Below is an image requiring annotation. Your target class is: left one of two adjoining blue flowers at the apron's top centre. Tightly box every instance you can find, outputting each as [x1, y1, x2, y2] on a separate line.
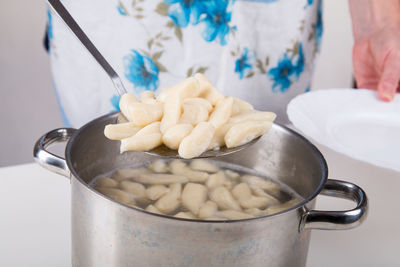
[164, 0, 204, 28]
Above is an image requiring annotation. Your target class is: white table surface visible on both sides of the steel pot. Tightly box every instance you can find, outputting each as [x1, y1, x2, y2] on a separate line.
[0, 146, 400, 267]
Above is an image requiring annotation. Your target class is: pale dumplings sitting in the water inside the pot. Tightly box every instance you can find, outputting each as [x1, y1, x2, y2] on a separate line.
[94, 159, 299, 221]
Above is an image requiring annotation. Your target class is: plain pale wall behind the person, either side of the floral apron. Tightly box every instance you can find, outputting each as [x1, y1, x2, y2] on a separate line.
[0, 0, 353, 167]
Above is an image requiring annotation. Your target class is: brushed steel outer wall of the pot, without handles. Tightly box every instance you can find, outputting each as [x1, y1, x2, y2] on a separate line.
[72, 179, 310, 267]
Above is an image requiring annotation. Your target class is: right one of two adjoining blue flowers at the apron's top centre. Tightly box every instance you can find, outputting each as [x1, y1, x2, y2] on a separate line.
[201, 0, 232, 45]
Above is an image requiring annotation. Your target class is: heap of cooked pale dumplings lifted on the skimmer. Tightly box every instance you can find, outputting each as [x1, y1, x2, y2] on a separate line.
[104, 73, 276, 159]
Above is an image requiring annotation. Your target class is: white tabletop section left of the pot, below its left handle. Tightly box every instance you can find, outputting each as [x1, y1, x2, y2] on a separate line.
[0, 163, 71, 267]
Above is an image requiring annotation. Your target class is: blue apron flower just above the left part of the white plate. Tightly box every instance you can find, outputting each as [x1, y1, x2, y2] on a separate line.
[268, 53, 296, 93]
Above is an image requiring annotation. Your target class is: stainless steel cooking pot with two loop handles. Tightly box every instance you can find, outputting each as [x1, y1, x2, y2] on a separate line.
[34, 113, 367, 267]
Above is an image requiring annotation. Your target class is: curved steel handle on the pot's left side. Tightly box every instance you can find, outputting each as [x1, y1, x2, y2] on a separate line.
[33, 128, 77, 178]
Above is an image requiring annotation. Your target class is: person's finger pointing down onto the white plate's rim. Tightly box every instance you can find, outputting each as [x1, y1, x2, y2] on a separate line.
[378, 53, 400, 101]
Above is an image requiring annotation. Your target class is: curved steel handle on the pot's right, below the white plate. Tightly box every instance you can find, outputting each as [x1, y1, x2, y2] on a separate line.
[300, 179, 368, 231]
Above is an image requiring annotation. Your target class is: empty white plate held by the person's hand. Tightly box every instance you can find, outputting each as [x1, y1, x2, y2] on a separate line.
[287, 89, 400, 171]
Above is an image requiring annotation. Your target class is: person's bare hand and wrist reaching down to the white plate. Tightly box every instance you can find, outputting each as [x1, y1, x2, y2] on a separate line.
[349, 0, 400, 101]
